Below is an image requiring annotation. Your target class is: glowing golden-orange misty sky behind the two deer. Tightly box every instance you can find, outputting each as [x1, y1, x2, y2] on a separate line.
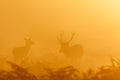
[0, 0, 120, 67]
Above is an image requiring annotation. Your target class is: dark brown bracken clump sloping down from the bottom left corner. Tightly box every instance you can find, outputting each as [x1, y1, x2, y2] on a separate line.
[0, 61, 38, 80]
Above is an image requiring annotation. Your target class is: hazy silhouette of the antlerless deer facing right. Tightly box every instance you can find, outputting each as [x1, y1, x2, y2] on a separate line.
[13, 38, 34, 61]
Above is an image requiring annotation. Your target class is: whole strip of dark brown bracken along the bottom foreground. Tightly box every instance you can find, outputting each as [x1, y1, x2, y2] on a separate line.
[0, 58, 120, 80]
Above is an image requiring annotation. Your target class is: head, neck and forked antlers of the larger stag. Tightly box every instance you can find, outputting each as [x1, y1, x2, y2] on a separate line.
[57, 33, 75, 52]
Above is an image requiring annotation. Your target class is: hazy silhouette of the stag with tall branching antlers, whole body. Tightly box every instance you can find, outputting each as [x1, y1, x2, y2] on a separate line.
[57, 33, 83, 59]
